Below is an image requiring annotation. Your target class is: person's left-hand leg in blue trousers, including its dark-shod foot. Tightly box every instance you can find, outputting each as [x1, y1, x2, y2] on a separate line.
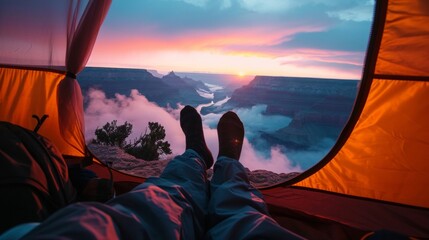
[21, 106, 213, 239]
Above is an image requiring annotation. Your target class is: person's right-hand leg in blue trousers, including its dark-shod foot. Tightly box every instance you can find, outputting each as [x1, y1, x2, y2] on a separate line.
[206, 112, 300, 239]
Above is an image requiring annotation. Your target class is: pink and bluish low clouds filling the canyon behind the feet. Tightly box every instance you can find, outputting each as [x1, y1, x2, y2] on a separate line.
[85, 89, 303, 173]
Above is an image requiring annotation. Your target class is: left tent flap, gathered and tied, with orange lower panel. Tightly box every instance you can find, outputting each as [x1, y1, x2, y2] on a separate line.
[0, 0, 112, 157]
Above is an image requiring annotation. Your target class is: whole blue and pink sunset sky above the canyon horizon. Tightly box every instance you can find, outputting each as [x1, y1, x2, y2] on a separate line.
[88, 0, 374, 79]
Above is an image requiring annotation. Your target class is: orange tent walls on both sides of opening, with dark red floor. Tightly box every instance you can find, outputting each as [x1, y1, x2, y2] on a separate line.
[0, 0, 429, 239]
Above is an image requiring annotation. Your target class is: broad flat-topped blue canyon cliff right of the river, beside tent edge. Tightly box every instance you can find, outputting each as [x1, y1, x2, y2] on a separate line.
[221, 76, 359, 150]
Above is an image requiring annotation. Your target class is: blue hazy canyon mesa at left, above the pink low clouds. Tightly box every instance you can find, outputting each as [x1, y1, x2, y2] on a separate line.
[78, 67, 211, 106]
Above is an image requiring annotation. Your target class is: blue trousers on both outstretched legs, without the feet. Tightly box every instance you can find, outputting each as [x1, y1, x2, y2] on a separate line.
[19, 150, 300, 239]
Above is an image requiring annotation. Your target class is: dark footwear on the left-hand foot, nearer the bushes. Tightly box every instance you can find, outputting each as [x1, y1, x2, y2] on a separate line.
[180, 105, 213, 169]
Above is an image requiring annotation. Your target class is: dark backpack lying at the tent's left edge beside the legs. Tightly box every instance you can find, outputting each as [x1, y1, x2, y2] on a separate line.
[0, 121, 76, 233]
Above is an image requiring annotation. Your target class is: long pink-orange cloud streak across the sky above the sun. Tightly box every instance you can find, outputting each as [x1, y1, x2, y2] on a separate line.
[93, 25, 326, 57]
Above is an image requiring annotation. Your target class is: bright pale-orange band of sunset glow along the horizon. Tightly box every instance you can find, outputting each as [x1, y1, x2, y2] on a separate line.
[88, 45, 361, 80]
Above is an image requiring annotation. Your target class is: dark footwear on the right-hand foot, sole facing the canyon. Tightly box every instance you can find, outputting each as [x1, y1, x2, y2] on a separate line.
[217, 111, 244, 160]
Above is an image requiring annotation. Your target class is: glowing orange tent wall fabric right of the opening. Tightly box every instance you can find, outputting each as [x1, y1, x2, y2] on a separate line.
[295, 1, 429, 208]
